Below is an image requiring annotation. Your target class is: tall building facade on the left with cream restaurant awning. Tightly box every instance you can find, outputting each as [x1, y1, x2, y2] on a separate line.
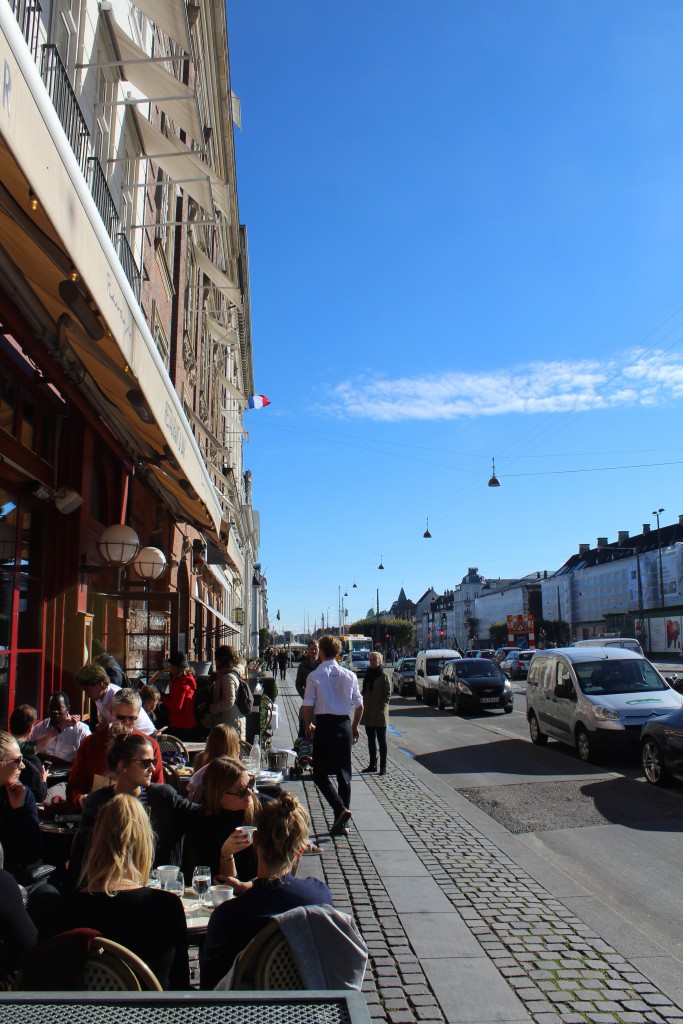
[0, 0, 259, 725]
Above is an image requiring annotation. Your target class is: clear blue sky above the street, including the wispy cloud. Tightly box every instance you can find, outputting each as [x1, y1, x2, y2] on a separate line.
[227, 0, 683, 631]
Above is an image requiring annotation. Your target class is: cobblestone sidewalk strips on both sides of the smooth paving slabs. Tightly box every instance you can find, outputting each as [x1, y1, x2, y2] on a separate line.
[279, 684, 683, 1024]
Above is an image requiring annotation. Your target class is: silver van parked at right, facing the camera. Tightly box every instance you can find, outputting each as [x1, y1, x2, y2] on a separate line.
[526, 646, 683, 761]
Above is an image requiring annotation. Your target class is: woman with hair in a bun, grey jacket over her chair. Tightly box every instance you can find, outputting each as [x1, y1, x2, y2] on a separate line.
[200, 792, 333, 988]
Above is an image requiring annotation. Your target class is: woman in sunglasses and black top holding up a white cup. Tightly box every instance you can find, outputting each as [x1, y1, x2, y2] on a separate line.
[183, 758, 261, 882]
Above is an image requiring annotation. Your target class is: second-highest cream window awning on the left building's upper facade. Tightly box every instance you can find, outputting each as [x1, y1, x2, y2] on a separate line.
[106, 16, 204, 143]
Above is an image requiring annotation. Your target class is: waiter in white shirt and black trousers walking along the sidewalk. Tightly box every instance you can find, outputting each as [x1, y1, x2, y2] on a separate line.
[303, 636, 362, 836]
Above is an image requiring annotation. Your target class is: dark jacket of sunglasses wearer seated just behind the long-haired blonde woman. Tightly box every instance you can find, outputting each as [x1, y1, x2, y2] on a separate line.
[70, 784, 203, 883]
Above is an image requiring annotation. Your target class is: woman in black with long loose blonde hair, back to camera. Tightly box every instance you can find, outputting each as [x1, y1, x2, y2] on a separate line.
[63, 794, 189, 989]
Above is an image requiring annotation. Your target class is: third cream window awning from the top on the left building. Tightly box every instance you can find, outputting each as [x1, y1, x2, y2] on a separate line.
[133, 110, 229, 217]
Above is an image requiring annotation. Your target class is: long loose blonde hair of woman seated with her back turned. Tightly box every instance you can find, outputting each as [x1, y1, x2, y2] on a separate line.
[78, 793, 155, 896]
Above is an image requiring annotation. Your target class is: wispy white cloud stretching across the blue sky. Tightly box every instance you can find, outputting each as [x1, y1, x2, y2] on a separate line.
[327, 349, 683, 422]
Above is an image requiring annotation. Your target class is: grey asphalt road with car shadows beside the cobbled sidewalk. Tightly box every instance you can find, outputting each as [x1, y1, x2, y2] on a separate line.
[390, 684, 683, 966]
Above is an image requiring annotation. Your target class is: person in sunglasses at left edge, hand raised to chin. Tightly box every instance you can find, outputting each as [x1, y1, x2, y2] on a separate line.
[0, 731, 41, 882]
